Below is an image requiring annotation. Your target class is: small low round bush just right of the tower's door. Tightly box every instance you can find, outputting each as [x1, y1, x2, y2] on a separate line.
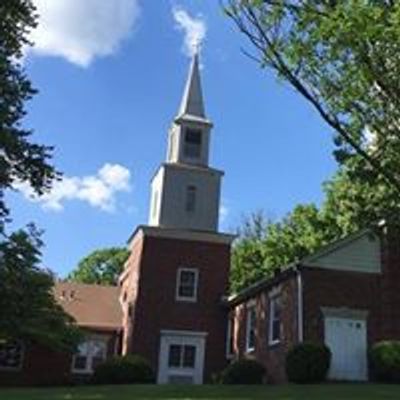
[220, 359, 265, 385]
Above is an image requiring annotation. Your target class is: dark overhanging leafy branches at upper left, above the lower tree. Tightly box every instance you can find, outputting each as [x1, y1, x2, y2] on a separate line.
[0, 0, 57, 234]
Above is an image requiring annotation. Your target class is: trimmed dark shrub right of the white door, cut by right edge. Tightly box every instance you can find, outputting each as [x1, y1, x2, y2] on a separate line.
[369, 340, 400, 383]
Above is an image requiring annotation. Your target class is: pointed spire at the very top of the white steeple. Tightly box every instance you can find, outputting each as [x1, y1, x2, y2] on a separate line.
[178, 52, 206, 119]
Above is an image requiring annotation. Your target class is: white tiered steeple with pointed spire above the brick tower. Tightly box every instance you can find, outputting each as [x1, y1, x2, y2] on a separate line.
[149, 54, 223, 232]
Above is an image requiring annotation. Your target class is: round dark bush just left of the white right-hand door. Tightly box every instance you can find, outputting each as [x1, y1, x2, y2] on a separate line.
[286, 343, 331, 383]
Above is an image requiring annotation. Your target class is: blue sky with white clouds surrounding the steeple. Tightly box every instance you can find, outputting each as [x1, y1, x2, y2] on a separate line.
[9, 0, 336, 276]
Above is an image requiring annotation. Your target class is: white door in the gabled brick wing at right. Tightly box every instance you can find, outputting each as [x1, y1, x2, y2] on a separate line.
[325, 317, 367, 381]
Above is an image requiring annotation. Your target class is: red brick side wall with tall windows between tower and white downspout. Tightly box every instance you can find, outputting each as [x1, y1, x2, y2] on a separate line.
[232, 276, 298, 383]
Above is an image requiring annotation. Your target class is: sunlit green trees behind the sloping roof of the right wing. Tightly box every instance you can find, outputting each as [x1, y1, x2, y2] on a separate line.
[231, 165, 398, 292]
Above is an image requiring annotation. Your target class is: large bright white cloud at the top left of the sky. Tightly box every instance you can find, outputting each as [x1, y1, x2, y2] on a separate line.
[28, 0, 139, 67]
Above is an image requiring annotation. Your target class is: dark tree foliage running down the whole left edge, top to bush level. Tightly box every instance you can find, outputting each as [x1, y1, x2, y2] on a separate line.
[0, 0, 80, 350]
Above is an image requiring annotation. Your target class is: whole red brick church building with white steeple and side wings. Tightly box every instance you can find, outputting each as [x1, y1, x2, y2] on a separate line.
[0, 55, 400, 385]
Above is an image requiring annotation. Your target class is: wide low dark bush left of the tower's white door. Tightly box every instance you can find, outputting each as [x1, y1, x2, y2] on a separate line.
[93, 355, 155, 384]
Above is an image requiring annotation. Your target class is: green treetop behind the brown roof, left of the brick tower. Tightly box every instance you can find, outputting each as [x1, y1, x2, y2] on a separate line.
[67, 247, 129, 285]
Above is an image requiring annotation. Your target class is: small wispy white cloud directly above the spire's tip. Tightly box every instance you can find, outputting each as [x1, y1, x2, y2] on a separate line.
[172, 6, 207, 56]
